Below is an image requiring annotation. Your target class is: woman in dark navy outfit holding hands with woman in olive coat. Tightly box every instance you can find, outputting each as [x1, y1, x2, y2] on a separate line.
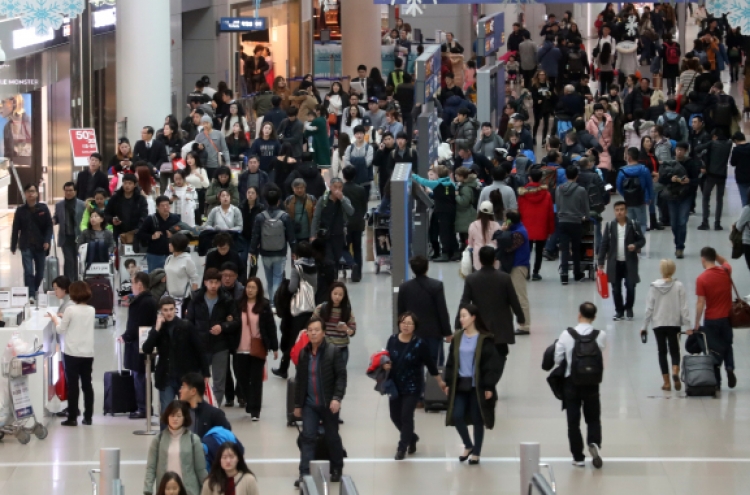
[383, 311, 445, 461]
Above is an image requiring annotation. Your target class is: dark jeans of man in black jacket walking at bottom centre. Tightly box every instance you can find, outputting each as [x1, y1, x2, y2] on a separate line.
[299, 404, 344, 475]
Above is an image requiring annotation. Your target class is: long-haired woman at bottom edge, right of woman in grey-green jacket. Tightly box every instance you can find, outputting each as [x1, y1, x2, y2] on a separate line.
[201, 442, 260, 495]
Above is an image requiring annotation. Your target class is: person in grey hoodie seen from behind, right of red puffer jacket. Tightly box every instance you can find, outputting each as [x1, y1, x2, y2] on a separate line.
[555, 165, 589, 285]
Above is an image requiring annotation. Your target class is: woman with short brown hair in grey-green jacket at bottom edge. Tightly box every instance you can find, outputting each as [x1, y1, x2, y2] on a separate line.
[143, 400, 207, 495]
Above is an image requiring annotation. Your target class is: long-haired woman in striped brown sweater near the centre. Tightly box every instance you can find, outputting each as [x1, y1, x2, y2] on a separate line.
[313, 281, 357, 363]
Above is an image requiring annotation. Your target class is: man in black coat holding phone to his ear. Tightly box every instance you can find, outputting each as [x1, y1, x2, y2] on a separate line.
[143, 296, 210, 420]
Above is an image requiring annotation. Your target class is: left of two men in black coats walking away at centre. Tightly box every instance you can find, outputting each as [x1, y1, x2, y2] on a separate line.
[398, 256, 453, 366]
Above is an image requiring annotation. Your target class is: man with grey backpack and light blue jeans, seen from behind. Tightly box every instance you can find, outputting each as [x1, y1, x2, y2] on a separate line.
[250, 184, 300, 306]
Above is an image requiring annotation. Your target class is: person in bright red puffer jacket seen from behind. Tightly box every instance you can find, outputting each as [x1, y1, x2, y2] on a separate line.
[518, 169, 555, 280]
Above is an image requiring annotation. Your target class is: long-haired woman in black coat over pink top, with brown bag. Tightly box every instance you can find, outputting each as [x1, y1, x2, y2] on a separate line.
[234, 277, 279, 421]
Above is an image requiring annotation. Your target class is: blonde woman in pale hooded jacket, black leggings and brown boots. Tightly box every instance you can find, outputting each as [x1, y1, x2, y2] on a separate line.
[641, 259, 690, 391]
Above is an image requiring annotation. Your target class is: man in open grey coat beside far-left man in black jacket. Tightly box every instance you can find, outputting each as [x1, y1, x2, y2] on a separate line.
[52, 182, 86, 281]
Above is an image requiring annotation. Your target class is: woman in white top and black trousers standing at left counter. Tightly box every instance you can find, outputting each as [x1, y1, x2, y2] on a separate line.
[47, 282, 95, 426]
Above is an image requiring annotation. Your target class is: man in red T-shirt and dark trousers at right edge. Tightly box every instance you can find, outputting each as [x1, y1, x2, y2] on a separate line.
[687, 247, 737, 390]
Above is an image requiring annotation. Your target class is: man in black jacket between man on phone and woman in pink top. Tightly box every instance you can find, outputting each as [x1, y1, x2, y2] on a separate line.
[185, 268, 241, 406]
